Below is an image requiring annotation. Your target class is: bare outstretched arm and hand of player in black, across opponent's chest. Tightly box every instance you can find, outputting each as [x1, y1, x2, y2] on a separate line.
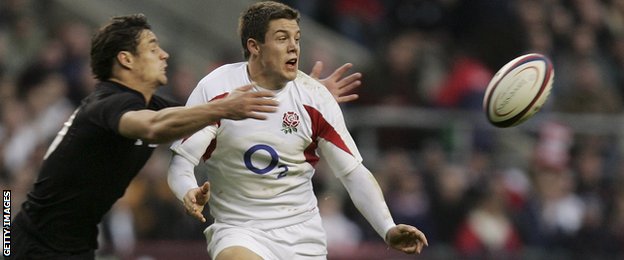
[119, 85, 278, 144]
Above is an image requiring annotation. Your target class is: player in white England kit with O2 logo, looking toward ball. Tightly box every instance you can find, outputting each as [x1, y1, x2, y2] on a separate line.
[168, 2, 427, 260]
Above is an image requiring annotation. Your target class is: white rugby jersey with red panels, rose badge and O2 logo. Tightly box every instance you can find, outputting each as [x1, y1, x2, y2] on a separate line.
[171, 62, 362, 228]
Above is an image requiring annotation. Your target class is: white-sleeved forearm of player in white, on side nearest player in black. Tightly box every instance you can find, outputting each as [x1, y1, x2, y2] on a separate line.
[167, 155, 198, 201]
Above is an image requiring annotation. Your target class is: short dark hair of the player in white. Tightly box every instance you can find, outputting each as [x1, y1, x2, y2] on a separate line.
[238, 1, 300, 59]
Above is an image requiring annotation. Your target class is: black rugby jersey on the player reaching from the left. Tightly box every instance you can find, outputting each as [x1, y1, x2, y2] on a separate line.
[22, 82, 180, 251]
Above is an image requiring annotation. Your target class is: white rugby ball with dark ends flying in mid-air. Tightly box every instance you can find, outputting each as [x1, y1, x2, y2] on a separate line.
[483, 53, 555, 127]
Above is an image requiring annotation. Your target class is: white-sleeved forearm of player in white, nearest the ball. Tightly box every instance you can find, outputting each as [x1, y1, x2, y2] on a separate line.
[339, 165, 395, 240]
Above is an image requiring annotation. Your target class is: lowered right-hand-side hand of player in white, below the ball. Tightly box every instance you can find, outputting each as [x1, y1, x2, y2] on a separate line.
[386, 224, 429, 254]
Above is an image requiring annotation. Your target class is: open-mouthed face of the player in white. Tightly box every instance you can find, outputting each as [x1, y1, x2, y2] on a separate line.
[259, 19, 301, 85]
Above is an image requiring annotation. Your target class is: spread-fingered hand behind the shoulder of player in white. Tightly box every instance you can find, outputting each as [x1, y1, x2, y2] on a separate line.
[310, 61, 362, 103]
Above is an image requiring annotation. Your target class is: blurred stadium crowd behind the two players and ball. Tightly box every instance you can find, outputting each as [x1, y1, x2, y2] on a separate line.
[0, 0, 624, 259]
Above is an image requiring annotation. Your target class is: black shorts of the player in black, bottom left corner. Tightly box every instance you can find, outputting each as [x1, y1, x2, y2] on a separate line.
[5, 212, 95, 260]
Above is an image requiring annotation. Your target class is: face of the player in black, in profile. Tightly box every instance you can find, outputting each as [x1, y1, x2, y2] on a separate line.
[135, 30, 169, 86]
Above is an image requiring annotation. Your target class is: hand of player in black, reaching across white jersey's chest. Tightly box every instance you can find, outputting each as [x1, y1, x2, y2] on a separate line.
[217, 84, 279, 120]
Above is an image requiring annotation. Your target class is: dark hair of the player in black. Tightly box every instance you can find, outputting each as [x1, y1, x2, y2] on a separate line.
[91, 14, 151, 80]
